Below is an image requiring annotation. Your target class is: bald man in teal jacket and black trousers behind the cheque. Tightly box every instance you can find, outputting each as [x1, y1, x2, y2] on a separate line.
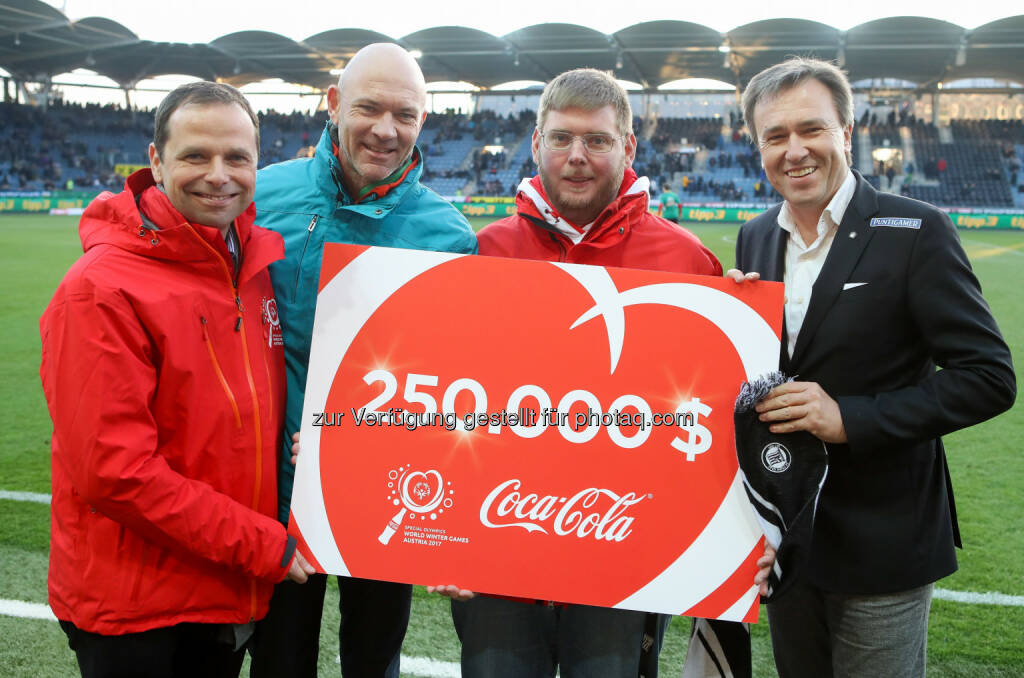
[251, 43, 476, 678]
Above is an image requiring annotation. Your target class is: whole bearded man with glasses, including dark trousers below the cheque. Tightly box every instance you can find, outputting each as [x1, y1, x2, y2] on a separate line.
[432, 69, 741, 678]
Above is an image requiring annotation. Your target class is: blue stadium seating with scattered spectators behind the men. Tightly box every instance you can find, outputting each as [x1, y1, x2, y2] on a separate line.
[0, 102, 1024, 207]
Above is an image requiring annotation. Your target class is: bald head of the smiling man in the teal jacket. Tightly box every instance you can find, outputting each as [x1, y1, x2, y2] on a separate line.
[327, 43, 427, 198]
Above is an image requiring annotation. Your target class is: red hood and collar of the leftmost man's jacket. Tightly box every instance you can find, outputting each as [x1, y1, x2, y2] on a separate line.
[78, 169, 285, 280]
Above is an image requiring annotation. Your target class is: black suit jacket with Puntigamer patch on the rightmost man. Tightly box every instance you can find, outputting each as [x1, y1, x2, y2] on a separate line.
[736, 173, 1016, 593]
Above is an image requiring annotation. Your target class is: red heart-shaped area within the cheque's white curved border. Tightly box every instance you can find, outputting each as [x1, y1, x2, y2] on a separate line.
[300, 248, 778, 605]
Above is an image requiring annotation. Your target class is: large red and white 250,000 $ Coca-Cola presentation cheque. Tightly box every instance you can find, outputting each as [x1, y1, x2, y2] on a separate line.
[289, 245, 782, 622]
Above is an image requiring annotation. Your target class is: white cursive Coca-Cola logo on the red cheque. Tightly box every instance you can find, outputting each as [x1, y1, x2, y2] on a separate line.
[480, 478, 646, 542]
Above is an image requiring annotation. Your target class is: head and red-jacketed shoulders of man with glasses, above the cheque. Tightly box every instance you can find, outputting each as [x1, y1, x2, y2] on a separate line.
[477, 69, 722, 276]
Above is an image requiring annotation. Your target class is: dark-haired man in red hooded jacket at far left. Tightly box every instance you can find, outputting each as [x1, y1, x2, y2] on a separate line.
[40, 82, 312, 677]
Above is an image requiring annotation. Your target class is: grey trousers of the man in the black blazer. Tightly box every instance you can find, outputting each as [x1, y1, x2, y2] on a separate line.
[768, 583, 934, 678]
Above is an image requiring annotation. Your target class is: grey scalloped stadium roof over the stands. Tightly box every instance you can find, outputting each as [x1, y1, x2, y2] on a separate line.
[0, 0, 1024, 89]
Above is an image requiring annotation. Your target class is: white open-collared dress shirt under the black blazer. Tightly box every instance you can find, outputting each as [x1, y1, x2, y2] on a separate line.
[778, 170, 857, 357]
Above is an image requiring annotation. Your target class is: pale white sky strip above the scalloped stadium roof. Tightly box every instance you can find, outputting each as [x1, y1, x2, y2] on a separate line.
[46, 0, 1024, 42]
